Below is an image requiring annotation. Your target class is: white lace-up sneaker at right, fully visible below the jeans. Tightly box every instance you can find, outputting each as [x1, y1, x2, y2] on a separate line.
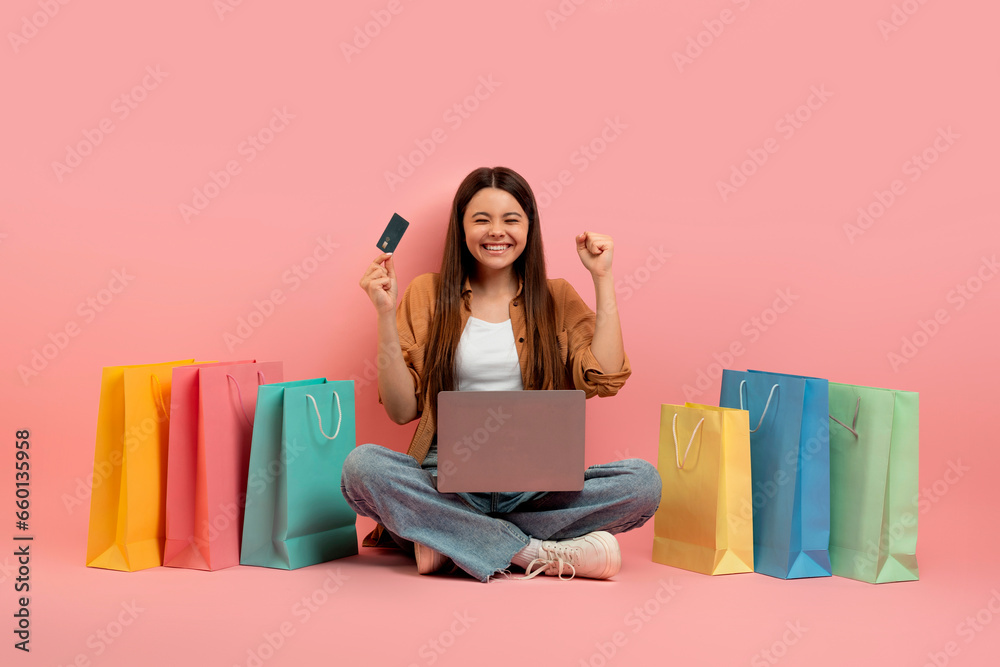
[522, 530, 622, 579]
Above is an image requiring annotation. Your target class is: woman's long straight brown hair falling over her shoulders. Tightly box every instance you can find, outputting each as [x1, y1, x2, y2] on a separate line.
[423, 167, 567, 419]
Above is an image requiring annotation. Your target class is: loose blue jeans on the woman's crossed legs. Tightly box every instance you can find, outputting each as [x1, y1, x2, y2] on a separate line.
[340, 444, 660, 581]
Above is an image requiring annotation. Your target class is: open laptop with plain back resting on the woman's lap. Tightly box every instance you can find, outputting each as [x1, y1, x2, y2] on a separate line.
[437, 389, 586, 493]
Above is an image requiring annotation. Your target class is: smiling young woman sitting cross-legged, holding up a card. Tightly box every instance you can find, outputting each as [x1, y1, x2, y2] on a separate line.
[341, 167, 660, 581]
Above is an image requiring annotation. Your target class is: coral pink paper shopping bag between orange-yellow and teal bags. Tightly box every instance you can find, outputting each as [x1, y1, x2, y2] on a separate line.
[163, 361, 283, 570]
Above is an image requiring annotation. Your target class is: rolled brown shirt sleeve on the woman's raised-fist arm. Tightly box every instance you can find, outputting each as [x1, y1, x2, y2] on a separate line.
[560, 280, 632, 398]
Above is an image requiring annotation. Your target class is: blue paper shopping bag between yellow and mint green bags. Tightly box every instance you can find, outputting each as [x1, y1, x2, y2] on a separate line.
[719, 370, 831, 579]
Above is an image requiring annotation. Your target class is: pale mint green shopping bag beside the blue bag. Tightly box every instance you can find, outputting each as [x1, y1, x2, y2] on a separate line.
[830, 382, 919, 584]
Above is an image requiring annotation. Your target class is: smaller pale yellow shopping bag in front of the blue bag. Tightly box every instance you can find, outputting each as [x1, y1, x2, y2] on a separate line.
[653, 403, 753, 574]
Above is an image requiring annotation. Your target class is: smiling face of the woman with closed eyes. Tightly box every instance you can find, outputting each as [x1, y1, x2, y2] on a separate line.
[462, 188, 528, 270]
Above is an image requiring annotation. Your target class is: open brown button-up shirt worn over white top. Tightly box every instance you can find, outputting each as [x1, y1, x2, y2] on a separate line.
[365, 273, 632, 546]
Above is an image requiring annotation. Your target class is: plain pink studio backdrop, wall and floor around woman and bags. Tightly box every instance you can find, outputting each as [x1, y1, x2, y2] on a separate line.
[0, 0, 1000, 666]
